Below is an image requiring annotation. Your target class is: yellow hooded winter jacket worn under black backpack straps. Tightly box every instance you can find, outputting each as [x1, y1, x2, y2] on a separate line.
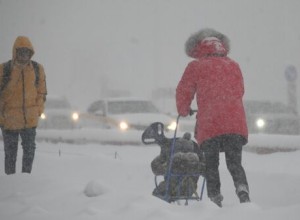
[0, 36, 47, 130]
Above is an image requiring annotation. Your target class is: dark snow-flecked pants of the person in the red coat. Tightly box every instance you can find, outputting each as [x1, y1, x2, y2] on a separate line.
[201, 134, 249, 198]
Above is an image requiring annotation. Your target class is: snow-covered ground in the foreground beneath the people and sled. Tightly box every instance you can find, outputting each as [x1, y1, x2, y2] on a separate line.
[0, 130, 300, 220]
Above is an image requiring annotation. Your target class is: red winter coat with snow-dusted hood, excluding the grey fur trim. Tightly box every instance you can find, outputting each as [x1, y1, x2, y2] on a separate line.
[176, 38, 248, 144]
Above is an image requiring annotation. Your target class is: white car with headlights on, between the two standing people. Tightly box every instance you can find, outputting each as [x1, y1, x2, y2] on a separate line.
[82, 97, 176, 131]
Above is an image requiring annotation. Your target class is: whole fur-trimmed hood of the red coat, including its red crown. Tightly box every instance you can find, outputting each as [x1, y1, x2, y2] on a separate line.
[185, 28, 230, 58]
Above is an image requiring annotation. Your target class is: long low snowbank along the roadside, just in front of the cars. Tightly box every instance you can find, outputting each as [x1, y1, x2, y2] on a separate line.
[0, 128, 300, 153]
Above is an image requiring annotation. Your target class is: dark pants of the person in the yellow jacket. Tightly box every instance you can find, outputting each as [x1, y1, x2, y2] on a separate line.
[2, 128, 36, 174]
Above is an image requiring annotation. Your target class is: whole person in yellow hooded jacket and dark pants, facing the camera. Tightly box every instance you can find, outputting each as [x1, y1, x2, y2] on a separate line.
[0, 36, 47, 174]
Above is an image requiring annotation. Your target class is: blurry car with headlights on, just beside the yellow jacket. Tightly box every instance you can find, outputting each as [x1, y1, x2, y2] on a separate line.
[38, 96, 79, 129]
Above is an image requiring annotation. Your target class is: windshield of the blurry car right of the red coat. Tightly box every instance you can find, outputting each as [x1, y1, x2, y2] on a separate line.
[245, 101, 292, 114]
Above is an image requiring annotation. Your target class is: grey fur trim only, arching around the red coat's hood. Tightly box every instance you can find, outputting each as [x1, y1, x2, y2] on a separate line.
[185, 28, 230, 58]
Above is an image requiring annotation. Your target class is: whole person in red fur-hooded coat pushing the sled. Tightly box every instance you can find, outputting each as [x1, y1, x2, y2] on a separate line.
[176, 28, 250, 207]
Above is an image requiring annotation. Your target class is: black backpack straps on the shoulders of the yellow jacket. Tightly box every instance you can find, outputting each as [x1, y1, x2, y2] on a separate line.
[0, 60, 40, 93]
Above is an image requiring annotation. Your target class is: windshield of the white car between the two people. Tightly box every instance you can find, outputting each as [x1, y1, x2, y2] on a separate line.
[107, 101, 158, 114]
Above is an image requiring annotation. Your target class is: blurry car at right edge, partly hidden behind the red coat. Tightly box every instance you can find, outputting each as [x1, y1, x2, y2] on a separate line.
[244, 100, 300, 135]
